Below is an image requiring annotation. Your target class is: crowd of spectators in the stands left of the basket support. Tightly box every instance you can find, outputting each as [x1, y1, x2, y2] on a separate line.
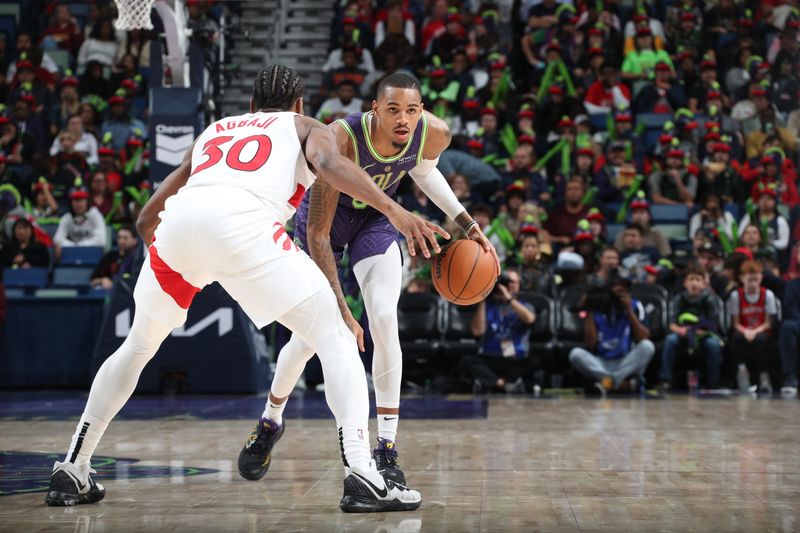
[0, 0, 228, 289]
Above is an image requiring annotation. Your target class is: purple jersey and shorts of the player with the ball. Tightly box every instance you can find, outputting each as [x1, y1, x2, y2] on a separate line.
[295, 112, 428, 265]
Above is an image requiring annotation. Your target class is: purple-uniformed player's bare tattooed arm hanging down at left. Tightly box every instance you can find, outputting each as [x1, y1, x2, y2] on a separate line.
[306, 180, 364, 352]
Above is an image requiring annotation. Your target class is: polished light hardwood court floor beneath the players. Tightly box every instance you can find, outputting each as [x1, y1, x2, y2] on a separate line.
[0, 396, 800, 533]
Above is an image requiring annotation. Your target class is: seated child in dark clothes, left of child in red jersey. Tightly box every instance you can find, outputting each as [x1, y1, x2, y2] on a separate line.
[660, 266, 722, 391]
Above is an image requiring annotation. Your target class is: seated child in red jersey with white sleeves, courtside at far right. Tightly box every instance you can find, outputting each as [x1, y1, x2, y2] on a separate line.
[728, 261, 778, 394]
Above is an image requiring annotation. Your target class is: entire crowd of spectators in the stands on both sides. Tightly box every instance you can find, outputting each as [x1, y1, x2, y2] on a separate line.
[0, 0, 800, 394]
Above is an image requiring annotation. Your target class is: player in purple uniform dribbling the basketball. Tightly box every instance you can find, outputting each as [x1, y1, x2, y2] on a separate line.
[239, 72, 500, 485]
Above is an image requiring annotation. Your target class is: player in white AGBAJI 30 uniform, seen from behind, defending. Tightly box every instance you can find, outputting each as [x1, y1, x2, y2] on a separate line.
[45, 65, 449, 512]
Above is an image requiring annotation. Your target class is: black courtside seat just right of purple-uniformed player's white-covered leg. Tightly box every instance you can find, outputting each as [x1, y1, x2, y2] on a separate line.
[397, 293, 442, 359]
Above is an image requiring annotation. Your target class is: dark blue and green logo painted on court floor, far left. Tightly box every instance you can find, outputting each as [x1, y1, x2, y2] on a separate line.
[0, 451, 219, 496]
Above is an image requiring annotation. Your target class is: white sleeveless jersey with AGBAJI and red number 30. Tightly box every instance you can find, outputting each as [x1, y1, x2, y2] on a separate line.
[185, 112, 314, 222]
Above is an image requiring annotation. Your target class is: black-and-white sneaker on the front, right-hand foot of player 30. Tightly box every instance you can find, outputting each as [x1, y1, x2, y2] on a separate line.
[339, 461, 422, 513]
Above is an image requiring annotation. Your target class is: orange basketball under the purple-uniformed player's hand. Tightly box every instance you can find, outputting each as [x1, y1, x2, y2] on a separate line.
[431, 239, 499, 305]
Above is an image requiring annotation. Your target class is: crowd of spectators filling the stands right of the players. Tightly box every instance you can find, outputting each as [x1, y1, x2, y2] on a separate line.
[318, 0, 800, 395]
